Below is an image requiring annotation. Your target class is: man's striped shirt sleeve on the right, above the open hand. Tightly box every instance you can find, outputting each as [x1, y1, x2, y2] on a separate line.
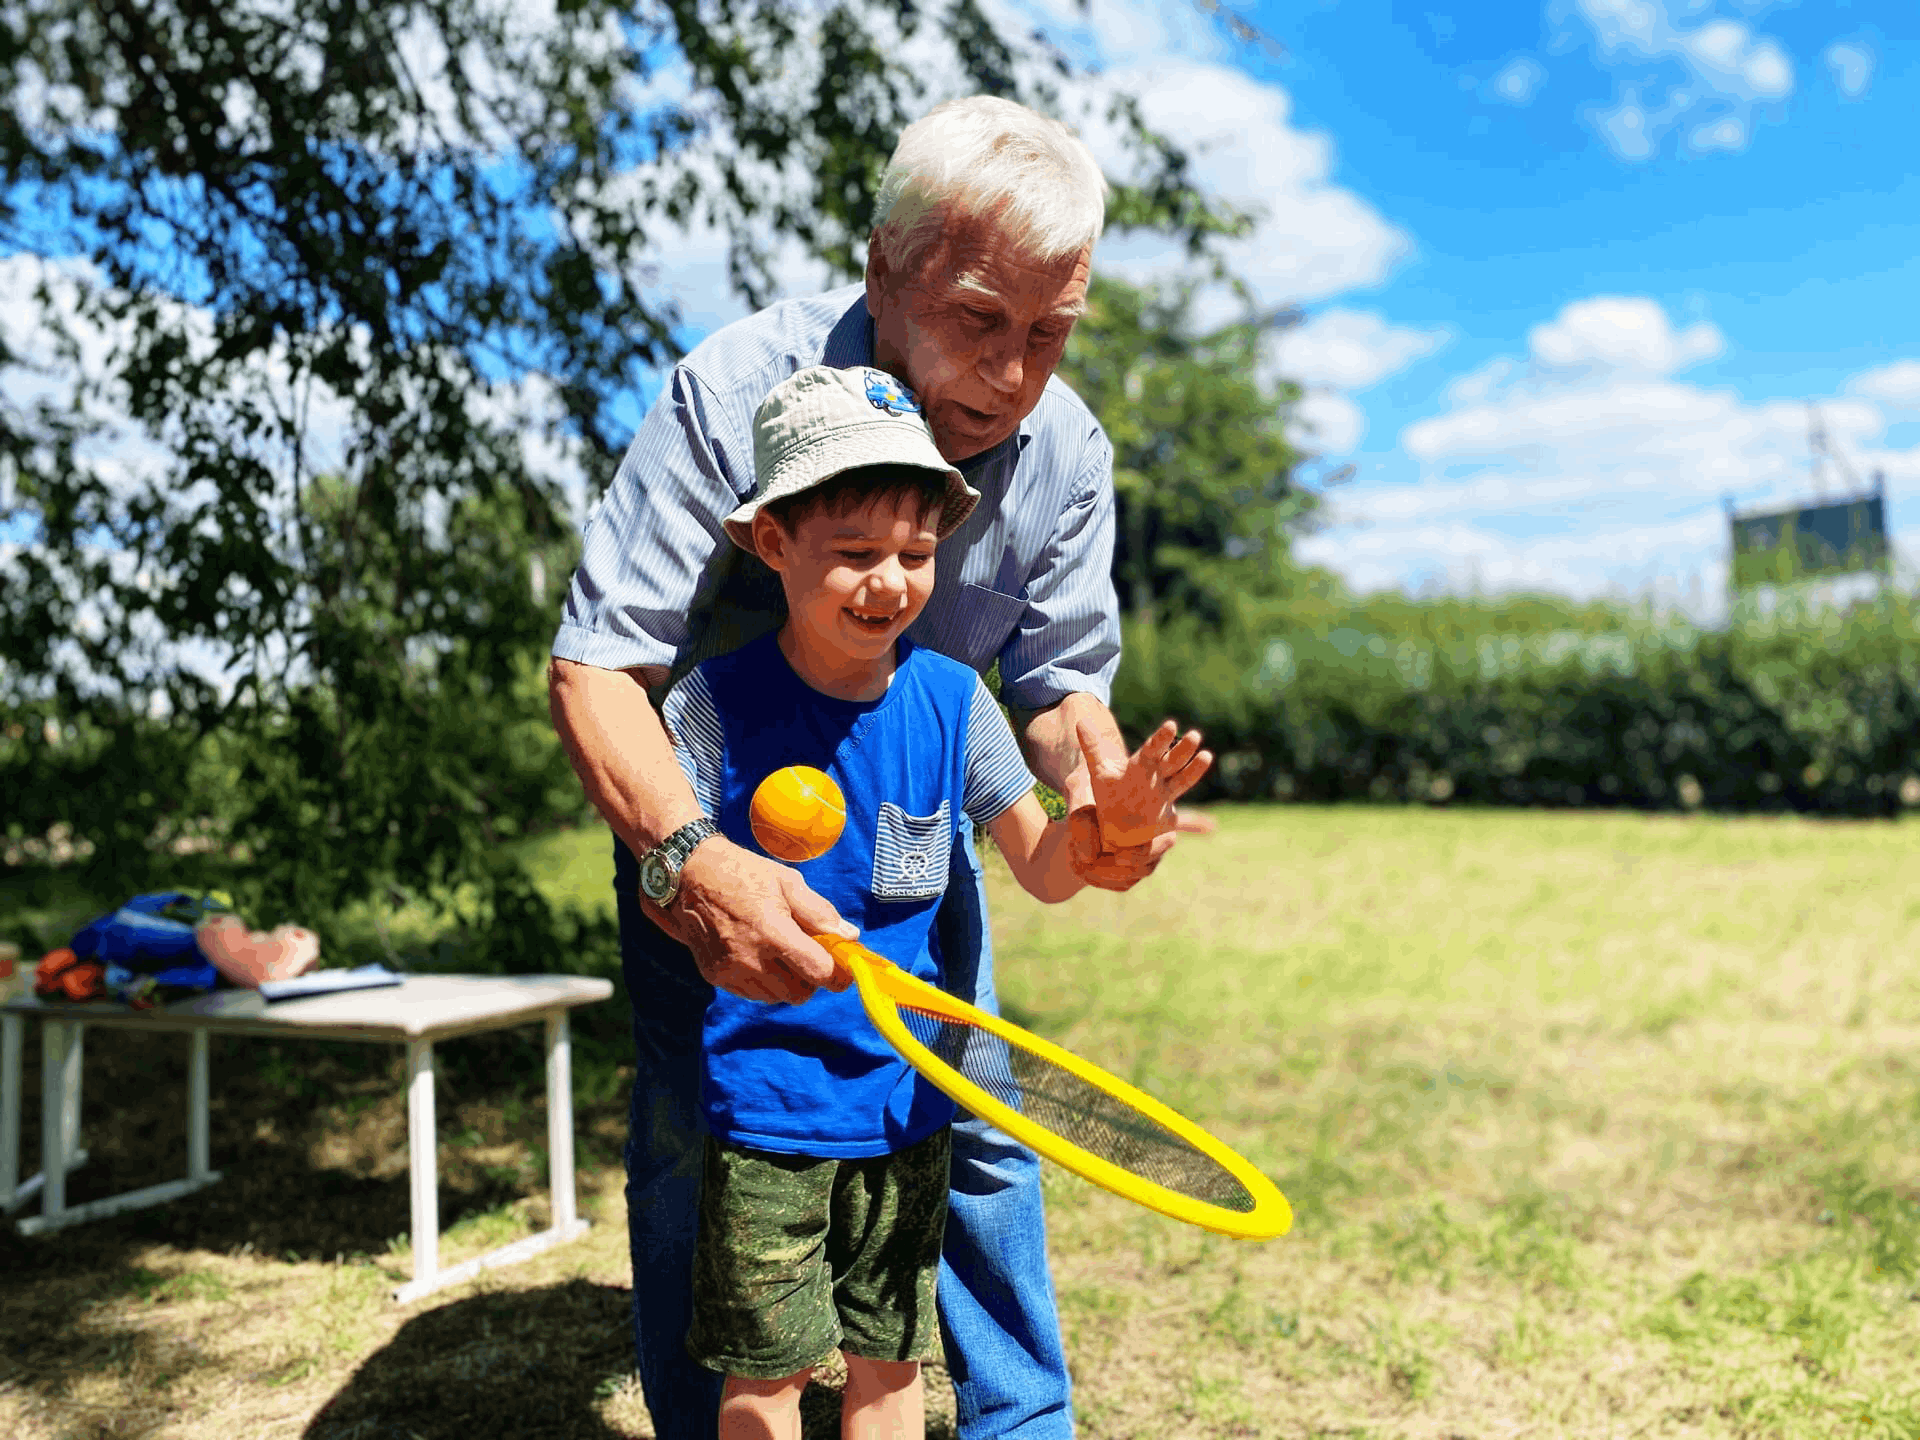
[1000, 428, 1119, 710]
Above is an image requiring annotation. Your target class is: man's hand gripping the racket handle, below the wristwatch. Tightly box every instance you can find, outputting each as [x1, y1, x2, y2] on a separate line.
[641, 835, 860, 1004]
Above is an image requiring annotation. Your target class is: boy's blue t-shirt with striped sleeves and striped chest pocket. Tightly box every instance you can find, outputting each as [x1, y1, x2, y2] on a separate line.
[664, 636, 1033, 1158]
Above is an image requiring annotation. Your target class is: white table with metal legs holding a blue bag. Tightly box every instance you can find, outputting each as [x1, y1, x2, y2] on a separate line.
[0, 975, 612, 1302]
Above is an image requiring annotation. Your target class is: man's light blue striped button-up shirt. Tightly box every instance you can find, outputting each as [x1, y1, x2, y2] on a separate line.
[553, 284, 1119, 710]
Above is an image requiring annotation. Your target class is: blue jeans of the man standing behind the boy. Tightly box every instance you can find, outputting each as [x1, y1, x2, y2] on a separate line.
[614, 822, 1073, 1440]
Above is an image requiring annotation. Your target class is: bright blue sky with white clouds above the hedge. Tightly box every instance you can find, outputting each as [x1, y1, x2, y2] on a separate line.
[1006, 0, 1920, 614]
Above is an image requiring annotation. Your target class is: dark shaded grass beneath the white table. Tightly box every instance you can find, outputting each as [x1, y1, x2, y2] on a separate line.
[0, 1027, 624, 1277]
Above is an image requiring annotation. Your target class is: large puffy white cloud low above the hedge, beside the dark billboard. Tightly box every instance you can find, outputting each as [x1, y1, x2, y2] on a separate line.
[1300, 296, 1920, 618]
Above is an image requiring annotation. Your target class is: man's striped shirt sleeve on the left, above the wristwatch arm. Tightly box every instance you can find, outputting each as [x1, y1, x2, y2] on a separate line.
[553, 365, 753, 670]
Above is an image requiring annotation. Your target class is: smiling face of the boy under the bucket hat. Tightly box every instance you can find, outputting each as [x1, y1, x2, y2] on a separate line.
[753, 492, 941, 670]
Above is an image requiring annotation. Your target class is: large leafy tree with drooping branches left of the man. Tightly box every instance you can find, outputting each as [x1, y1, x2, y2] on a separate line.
[0, 0, 1236, 964]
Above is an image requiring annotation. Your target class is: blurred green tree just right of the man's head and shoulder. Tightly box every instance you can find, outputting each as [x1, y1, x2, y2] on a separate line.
[1060, 278, 1313, 624]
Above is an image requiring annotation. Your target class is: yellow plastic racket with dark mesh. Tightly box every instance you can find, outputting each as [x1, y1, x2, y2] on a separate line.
[814, 935, 1294, 1240]
